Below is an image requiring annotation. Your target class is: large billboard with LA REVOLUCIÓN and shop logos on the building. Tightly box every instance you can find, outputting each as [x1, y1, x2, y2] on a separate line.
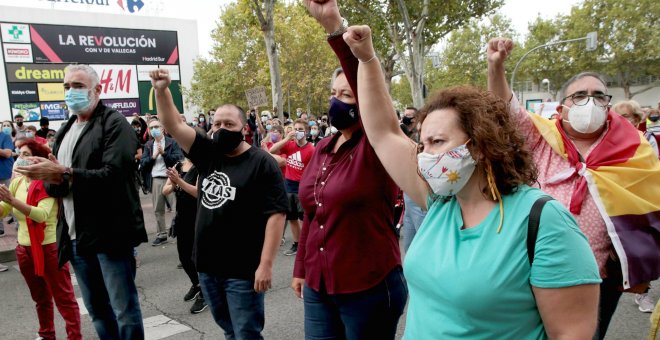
[0, 22, 183, 121]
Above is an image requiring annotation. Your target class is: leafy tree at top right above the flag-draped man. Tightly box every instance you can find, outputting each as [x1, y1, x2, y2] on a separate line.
[566, 0, 660, 99]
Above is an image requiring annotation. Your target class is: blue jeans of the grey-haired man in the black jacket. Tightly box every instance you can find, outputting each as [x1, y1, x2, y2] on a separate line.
[71, 240, 144, 340]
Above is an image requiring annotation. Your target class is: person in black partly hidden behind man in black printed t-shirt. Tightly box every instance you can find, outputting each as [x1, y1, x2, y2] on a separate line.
[163, 158, 207, 314]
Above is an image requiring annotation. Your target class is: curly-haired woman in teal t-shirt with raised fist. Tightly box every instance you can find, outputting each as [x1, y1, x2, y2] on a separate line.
[344, 26, 600, 339]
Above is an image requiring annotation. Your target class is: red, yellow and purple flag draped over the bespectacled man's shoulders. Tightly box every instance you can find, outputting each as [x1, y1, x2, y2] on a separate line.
[528, 112, 660, 288]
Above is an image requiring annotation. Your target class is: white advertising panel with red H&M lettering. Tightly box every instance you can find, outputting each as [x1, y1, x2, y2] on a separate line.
[90, 65, 139, 99]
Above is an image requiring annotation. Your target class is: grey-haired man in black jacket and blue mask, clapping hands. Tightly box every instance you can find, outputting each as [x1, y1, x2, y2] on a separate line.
[16, 65, 147, 339]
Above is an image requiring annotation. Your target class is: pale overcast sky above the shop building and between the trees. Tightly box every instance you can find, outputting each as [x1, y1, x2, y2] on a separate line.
[0, 0, 577, 56]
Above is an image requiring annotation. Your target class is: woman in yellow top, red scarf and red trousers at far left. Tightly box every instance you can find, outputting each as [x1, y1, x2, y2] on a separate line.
[0, 137, 82, 339]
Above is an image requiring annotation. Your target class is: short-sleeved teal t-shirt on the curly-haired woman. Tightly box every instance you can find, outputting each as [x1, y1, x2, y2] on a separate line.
[404, 186, 601, 340]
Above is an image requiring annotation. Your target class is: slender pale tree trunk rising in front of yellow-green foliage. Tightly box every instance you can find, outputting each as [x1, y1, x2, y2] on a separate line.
[250, 0, 282, 113]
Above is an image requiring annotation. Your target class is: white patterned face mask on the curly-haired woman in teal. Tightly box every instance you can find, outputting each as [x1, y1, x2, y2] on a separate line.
[417, 144, 476, 197]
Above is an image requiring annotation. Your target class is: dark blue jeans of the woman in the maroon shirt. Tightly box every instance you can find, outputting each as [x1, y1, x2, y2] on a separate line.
[303, 268, 408, 340]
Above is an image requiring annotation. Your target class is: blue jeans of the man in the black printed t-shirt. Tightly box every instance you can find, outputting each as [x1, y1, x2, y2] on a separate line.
[199, 272, 265, 340]
